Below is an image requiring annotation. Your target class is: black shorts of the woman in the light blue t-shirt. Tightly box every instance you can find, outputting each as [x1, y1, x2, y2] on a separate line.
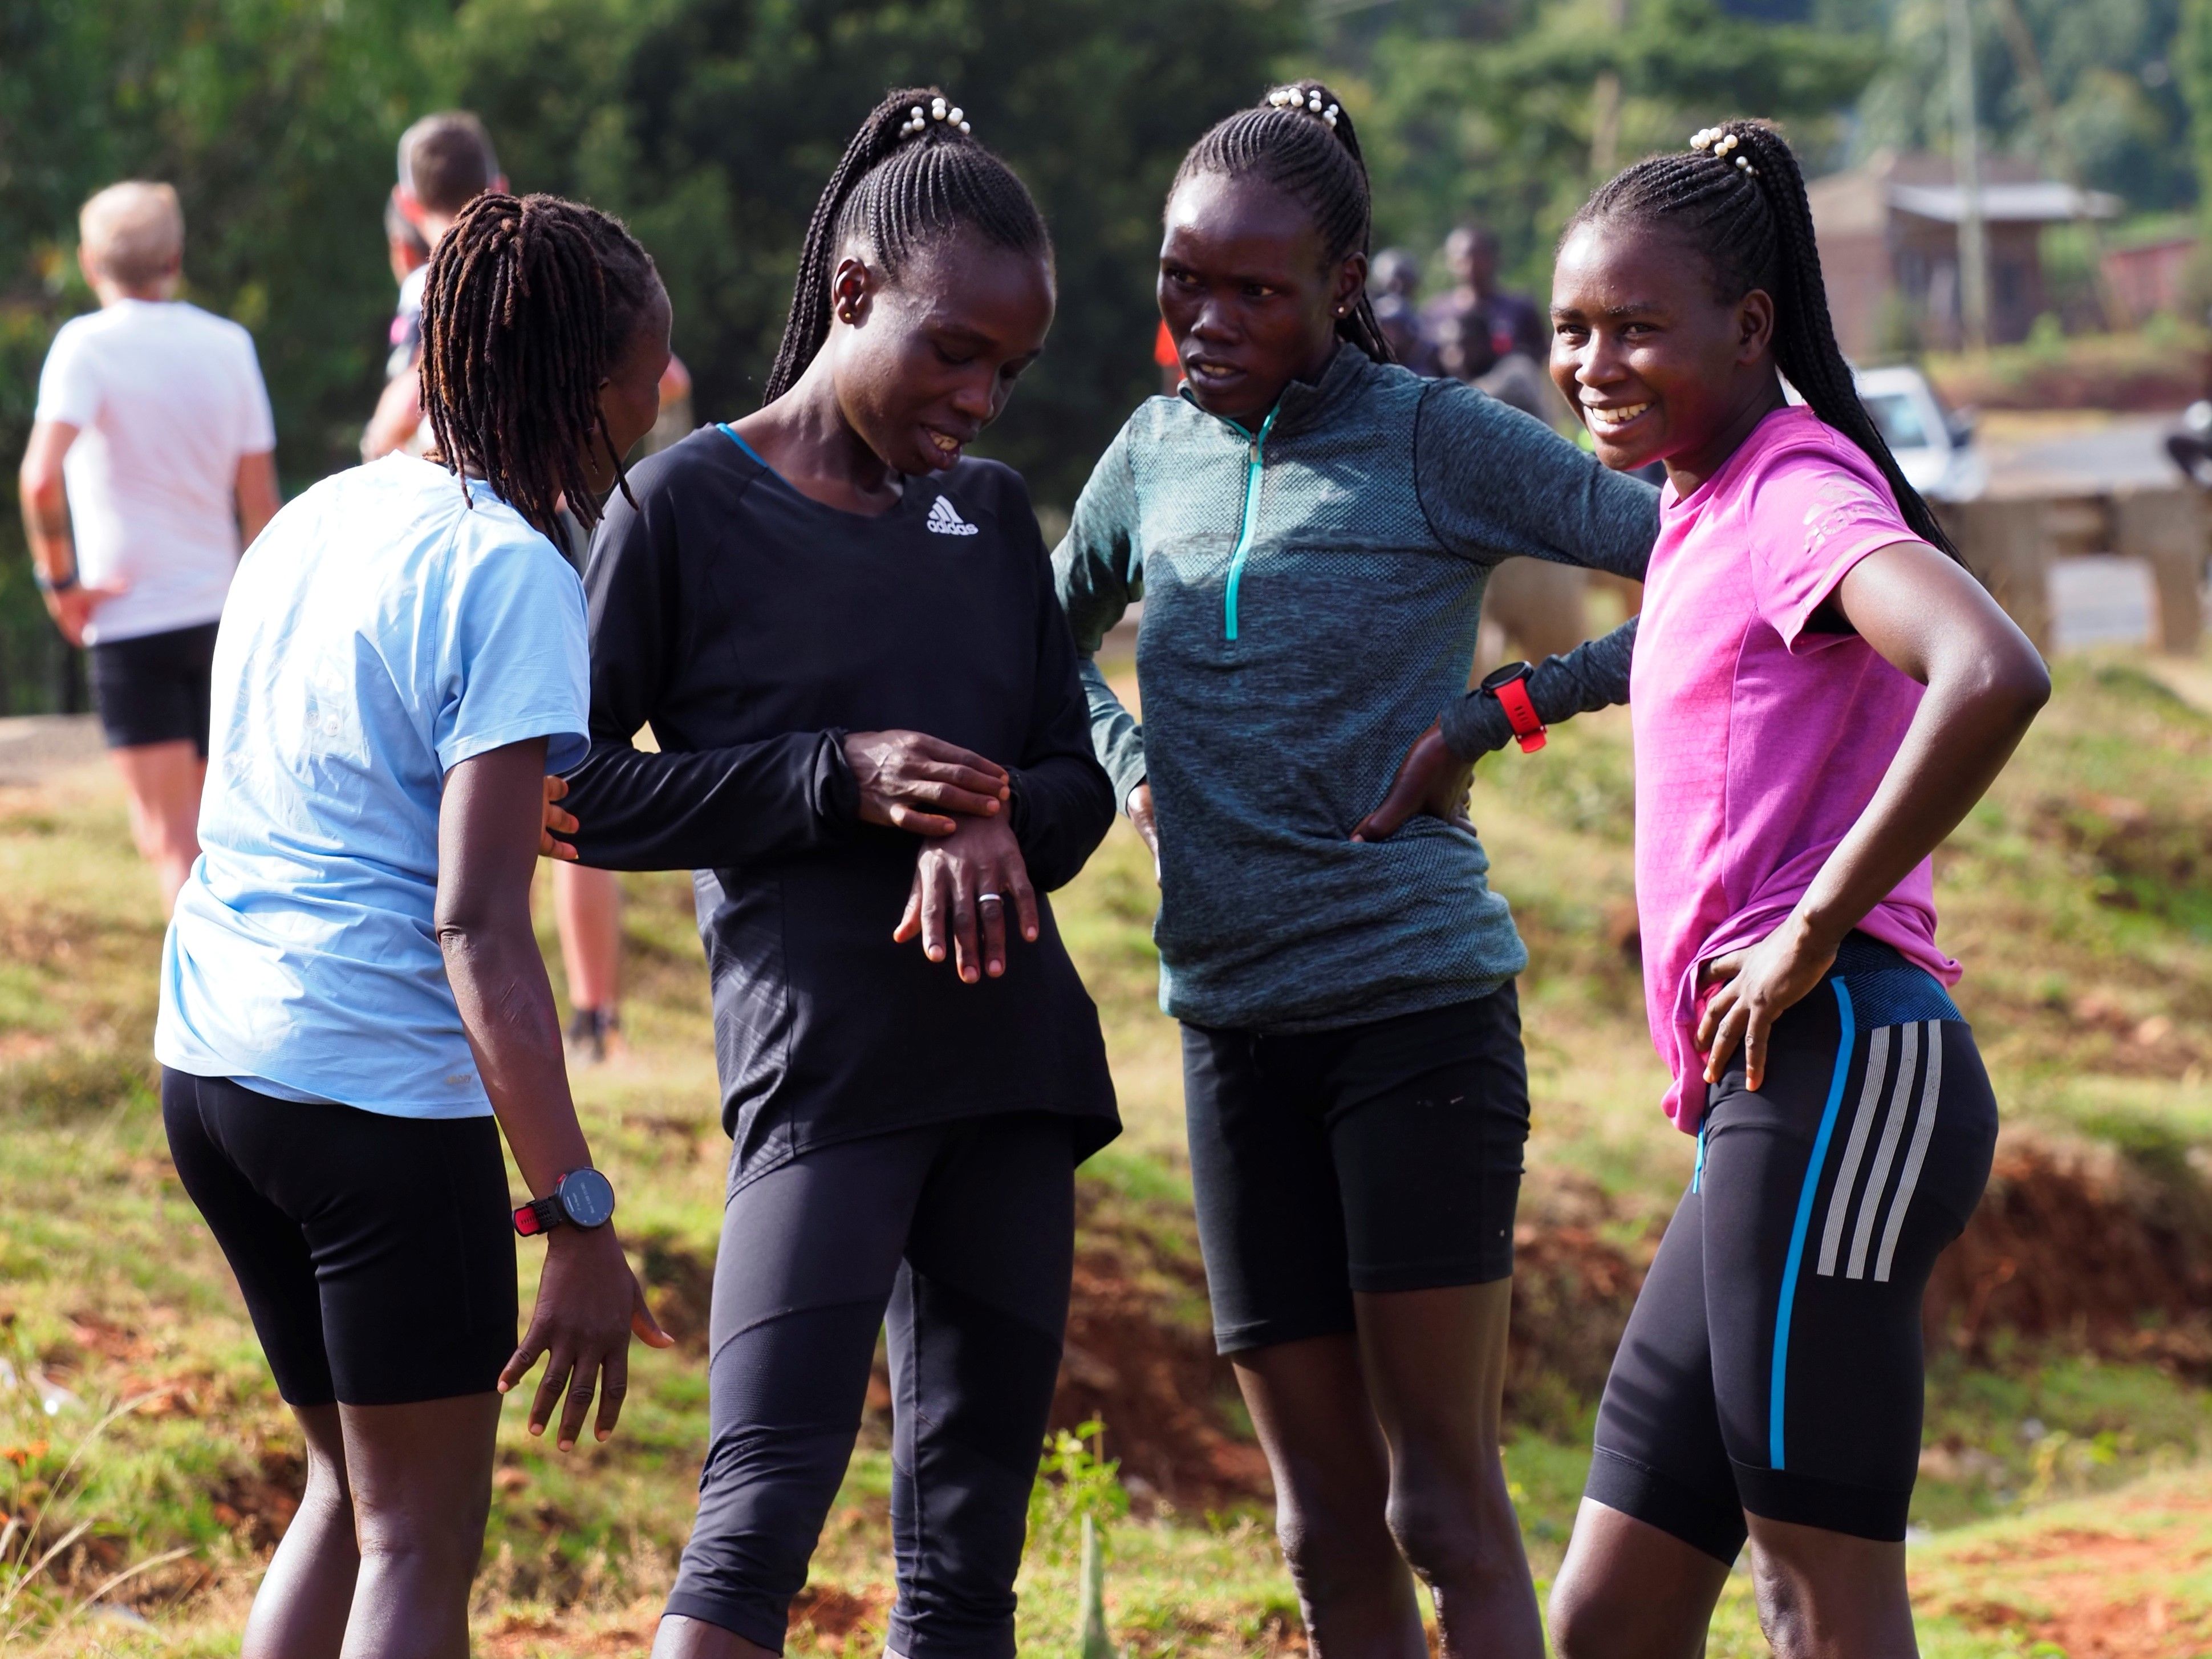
[161, 1066, 516, 1405]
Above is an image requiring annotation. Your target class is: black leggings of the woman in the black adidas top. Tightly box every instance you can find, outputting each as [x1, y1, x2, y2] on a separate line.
[668, 1113, 1075, 1659]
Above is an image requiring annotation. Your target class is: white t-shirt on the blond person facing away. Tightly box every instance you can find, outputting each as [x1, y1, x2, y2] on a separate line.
[38, 299, 277, 646]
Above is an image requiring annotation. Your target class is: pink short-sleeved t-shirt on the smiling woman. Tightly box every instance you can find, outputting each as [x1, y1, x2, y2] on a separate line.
[1630, 407, 1958, 1133]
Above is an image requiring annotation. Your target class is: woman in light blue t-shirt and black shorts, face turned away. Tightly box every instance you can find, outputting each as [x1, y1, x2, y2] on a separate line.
[155, 194, 668, 1659]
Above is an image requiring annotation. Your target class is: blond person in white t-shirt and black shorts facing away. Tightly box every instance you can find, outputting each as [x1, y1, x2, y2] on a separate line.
[22, 179, 279, 907]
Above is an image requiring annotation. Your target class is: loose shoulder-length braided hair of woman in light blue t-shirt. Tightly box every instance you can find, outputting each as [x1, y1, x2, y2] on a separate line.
[423, 194, 661, 542]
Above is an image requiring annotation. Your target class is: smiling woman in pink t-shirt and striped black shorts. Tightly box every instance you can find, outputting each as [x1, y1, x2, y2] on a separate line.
[1551, 121, 2051, 1659]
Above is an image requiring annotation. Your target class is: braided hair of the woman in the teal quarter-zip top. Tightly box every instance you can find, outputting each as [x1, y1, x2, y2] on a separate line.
[1168, 80, 1398, 363]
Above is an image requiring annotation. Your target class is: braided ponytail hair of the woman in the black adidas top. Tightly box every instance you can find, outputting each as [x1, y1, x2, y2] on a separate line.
[761, 86, 1053, 403]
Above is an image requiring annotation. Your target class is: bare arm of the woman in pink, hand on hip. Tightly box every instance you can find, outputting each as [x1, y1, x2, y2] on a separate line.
[1696, 542, 2051, 1088]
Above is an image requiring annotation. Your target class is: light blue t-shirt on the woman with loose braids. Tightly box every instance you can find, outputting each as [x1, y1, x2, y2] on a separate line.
[155, 456, 591, 1117]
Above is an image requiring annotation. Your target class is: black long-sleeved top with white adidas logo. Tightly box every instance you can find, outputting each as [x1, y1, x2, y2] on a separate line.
[564, 427, 1119, 1188]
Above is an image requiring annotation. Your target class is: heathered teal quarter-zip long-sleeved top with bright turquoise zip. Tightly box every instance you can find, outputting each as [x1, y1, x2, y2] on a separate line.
[1053, 345, 1659, 1031]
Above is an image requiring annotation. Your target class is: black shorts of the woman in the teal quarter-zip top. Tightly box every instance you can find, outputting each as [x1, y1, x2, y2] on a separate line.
[1183, 984, 1528, 1354]
